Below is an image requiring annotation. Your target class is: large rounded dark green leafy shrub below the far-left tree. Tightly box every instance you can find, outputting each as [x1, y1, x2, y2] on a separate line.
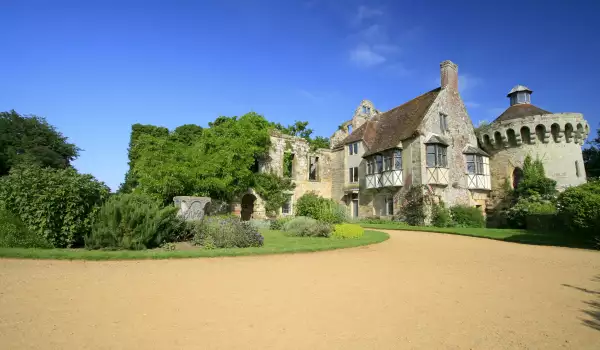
[0, 166, 109, 248]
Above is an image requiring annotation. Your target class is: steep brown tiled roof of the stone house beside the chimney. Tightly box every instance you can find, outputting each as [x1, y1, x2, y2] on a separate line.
[343, 88, 441, 156]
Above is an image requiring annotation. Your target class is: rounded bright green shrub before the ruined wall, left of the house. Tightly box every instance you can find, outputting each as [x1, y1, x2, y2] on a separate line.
[296, 192, 348, 224]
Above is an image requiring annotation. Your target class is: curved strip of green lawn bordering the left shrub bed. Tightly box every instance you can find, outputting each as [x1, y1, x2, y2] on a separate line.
[0, 230, 389, 260]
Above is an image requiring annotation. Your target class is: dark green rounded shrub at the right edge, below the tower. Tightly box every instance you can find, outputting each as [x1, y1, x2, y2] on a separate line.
[557, 180, 600, 238]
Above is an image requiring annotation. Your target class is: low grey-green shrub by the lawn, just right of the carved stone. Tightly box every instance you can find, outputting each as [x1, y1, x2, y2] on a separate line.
[193, 216, 264, 249]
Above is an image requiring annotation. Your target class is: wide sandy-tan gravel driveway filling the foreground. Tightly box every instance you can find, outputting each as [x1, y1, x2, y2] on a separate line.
[0, 231, 600, 350]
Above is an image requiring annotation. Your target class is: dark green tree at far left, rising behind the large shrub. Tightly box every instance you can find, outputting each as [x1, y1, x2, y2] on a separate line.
[0, 110, 80, 176]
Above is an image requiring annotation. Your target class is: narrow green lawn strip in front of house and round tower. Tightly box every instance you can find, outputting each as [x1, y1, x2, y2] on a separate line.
[360, 222, 597, 249]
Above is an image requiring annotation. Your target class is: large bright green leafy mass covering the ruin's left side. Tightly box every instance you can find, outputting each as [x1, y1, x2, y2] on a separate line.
[129, 113, 271, 203]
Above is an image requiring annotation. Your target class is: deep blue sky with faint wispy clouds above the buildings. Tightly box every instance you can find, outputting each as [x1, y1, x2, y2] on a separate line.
[0, 0, 600, 189]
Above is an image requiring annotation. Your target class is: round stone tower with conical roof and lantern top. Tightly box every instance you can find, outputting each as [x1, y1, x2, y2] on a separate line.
[477, 85, 589, 204]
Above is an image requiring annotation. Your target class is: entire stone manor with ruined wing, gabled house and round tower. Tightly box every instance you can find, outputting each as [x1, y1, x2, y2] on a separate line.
[232, 61, 589, 219]
